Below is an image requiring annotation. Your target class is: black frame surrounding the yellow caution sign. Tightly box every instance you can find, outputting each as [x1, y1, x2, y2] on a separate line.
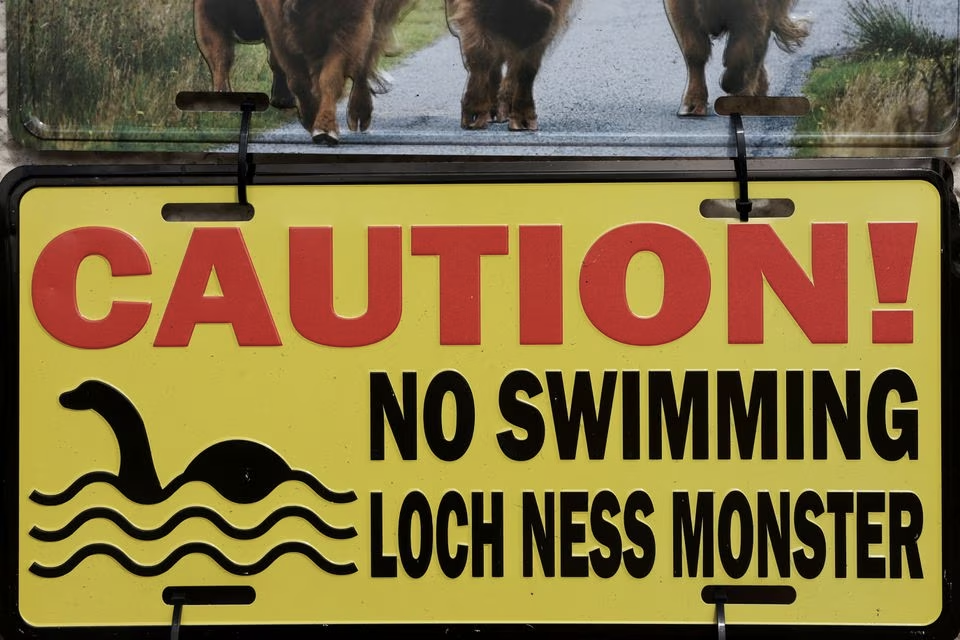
[0, 157, 960, 640]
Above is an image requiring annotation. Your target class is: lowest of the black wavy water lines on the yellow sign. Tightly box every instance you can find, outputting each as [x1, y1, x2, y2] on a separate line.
[30, 542, 357, 578]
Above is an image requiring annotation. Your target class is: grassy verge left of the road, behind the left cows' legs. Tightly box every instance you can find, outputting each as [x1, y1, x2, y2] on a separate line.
[10, 0, 447, 151]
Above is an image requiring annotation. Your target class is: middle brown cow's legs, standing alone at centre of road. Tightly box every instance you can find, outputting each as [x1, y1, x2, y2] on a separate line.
[446, 0, 573, 131]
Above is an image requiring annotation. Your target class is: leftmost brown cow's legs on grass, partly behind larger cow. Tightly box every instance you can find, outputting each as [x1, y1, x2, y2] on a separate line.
[193, 0, 293, 109]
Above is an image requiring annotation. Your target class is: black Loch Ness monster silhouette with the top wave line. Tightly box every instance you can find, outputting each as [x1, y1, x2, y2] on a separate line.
[30, 380, 357, 506]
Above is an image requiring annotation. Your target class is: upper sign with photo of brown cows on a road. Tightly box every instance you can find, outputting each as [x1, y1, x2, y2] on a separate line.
[6, 0, 960, 157]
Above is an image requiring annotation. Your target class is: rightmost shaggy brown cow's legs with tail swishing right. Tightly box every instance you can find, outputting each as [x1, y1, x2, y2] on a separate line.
[663, 0, 810, 116]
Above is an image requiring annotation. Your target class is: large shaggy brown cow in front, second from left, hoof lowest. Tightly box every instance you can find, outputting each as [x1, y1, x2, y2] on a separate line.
[256, 0, 412, 144]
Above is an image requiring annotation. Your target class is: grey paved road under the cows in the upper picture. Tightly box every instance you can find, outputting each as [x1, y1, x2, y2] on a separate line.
[252, 0, 958, 156]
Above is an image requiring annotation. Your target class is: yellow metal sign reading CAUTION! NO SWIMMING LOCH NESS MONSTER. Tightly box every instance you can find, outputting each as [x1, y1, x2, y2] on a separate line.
[5, 168, 952, 630]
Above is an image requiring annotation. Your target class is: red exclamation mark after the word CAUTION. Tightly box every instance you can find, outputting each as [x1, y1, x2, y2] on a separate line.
[870, 222, 918, 344]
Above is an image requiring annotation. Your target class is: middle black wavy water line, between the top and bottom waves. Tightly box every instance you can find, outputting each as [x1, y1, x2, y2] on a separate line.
[30, 505, 357, 542]
